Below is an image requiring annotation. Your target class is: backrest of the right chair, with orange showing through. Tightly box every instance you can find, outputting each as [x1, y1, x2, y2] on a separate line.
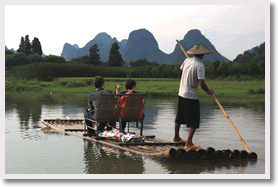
[120, 93, 147, 122]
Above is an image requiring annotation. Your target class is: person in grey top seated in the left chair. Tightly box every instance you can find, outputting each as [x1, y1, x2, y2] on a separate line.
[85, 76, 121, 134]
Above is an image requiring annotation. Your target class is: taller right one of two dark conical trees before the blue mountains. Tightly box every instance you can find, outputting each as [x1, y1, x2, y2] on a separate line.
[108, 42, 125, 67]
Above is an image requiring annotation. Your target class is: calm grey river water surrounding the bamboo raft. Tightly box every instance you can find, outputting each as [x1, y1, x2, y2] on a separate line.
[5, 94, 265, 174]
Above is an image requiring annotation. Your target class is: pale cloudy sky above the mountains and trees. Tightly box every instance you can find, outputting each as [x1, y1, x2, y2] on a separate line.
[5, 1, 266, 60]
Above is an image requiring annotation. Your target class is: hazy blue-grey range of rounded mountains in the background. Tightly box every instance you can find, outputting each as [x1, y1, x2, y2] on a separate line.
[61, 29, 230, 64]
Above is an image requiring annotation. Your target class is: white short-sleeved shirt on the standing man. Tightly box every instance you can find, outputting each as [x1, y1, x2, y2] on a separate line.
[179, 56, 205, 100]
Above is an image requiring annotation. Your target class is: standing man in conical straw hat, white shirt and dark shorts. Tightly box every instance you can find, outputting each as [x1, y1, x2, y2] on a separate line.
[173, 43, 214, 149]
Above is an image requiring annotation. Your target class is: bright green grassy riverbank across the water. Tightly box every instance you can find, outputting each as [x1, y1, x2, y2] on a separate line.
[5, 77, 265, 103]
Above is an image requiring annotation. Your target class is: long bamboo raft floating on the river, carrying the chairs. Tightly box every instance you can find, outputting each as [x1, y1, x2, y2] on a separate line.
[41, 119, 257, 159]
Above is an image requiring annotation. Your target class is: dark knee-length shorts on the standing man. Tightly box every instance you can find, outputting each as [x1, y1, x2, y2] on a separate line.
[175, 96, 200, 128]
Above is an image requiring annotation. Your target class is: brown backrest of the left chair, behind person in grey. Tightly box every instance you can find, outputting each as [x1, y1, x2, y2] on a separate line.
[95, 94, 119, 123]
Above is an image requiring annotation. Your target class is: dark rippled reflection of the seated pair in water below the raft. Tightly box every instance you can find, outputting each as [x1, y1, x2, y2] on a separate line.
[81, 139, 144, 174]
